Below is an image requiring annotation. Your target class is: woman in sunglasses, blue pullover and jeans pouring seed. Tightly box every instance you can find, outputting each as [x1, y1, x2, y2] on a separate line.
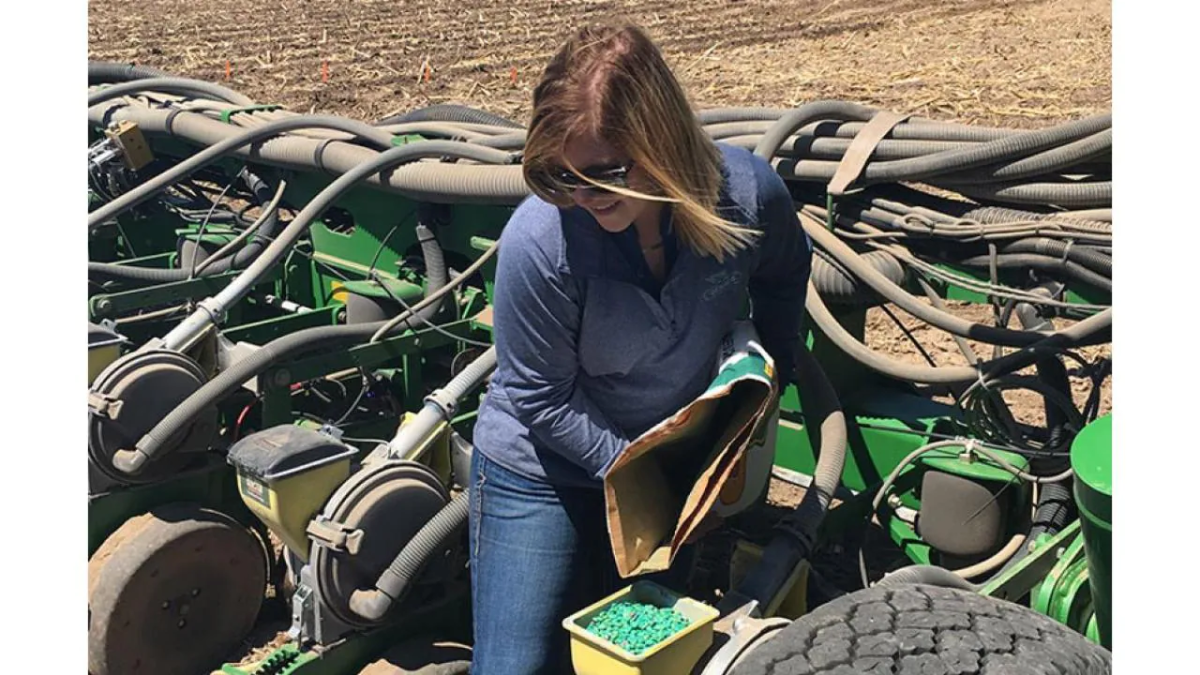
[470, 25, 811, 675]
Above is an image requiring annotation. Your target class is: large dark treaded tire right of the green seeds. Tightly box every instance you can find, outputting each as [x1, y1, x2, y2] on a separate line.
[731, 585, 1112, 675]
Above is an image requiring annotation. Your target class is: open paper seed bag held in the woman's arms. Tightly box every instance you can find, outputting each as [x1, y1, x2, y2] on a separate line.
[604, 322, 776, 578]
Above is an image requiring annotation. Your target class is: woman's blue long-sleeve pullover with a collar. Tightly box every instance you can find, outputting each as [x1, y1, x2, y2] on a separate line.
[473, 144, 812, 486]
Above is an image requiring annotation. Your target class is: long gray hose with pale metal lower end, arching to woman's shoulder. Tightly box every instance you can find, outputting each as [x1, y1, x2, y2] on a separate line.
[156, 141, 512, 350]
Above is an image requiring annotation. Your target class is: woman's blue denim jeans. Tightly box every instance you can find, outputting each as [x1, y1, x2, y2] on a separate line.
[469, 450, 692, 675]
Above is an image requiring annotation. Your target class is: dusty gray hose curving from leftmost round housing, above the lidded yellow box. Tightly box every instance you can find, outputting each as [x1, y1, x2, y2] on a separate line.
[114, 216, 449, 473]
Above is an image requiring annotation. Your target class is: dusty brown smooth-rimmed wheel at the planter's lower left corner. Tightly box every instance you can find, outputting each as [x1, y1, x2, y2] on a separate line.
[88, 504, 268, 675]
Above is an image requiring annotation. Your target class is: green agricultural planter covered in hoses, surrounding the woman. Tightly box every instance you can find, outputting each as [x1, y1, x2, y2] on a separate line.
[89, 64, 1112, 675]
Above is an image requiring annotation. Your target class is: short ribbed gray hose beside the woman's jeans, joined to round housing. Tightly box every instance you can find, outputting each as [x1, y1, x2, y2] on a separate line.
[350, 490, 470, 621]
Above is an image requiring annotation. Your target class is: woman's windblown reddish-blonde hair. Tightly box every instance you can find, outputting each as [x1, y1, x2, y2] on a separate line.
[523, 23, 756, 261]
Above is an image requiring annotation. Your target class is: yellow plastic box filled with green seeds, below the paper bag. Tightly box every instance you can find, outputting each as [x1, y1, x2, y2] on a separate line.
[563, 581, 719, 675]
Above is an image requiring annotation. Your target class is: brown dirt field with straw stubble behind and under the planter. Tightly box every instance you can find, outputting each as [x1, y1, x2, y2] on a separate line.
[88, 0, 1112, 656]
